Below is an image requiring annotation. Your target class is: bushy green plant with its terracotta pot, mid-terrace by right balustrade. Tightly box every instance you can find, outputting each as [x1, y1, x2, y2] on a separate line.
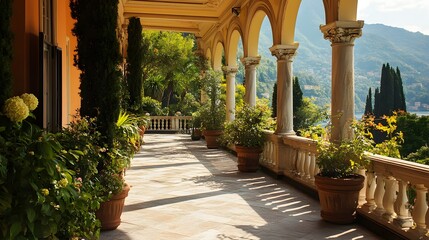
[222, 105, 270, 172]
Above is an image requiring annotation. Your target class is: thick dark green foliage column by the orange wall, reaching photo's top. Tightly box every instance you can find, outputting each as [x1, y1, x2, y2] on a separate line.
[70, 0, 121, 146]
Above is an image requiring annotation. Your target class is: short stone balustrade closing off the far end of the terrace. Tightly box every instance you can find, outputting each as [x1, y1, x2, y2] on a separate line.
[146, 116, 192, 132]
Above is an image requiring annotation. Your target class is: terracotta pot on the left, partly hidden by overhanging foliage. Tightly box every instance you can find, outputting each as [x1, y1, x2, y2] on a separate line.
[95, 184, 130, 231]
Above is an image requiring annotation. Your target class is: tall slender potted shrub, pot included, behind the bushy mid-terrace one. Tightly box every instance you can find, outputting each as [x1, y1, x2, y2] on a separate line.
[199, 68, 226, 148]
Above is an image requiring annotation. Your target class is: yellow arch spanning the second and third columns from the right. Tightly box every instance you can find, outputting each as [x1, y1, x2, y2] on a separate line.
[244, 1, 276, 57]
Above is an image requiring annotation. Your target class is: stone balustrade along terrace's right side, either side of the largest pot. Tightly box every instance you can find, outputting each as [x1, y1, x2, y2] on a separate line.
[260, 132, 429, 239]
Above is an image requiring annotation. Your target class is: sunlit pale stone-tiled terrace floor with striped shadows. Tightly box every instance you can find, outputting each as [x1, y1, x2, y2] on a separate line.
[101, 134, 381, 240]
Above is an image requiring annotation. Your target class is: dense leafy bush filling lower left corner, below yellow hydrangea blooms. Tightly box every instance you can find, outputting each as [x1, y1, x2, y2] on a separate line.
[0, 96, 99, 240]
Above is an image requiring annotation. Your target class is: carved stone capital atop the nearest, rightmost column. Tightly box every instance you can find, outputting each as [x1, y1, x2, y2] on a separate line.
[320, 21, 363, 44]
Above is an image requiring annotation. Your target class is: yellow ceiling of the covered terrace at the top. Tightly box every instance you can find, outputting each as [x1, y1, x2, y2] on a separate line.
[123, 0, 241, 37]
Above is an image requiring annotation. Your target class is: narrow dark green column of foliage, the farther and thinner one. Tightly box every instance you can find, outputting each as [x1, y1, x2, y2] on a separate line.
[126, 17, 144, 109]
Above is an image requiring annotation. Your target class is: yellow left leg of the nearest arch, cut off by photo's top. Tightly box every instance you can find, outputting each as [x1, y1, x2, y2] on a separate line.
[280, 0, 301, 45]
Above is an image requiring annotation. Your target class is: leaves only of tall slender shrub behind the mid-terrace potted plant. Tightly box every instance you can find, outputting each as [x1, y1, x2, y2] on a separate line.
[199, 69, 226, 130]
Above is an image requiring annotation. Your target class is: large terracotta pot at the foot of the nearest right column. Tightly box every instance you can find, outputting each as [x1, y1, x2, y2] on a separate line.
[315, 174, 365, 224]
